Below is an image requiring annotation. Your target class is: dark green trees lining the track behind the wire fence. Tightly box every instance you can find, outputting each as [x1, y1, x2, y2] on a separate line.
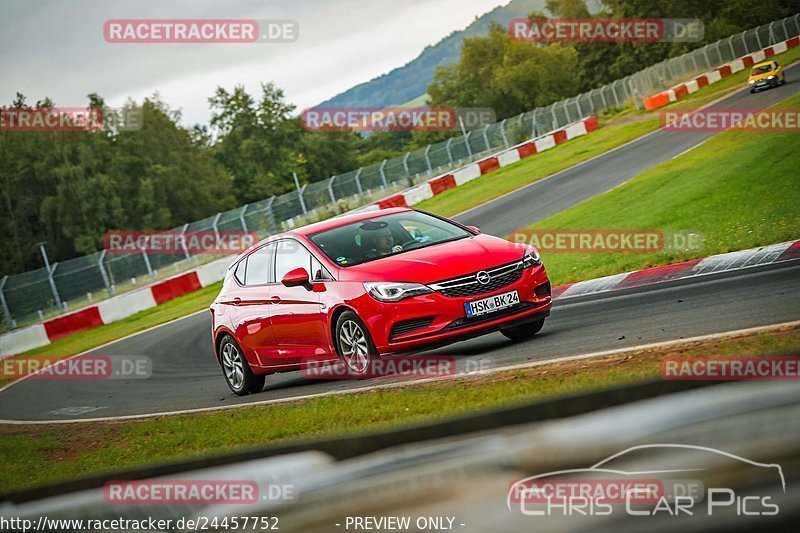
[0, 0, 800, 274]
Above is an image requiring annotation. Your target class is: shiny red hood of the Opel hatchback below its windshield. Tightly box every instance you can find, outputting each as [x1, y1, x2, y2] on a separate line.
[339, 235, 527, 283]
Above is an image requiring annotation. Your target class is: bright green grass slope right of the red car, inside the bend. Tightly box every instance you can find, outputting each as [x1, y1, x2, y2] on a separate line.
[530, 90, 800, 284]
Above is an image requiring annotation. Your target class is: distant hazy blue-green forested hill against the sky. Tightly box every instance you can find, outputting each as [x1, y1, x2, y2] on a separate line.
[319, 0, 545, 107]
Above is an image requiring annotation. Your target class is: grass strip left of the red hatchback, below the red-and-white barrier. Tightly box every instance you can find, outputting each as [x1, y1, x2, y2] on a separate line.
[0, 282, 222, 386]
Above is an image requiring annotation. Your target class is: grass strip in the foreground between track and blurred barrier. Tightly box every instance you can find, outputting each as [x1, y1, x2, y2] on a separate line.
[0, 327, 800, 492]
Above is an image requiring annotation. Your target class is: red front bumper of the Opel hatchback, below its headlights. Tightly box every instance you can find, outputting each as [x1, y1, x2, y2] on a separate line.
[359, 265, 552, 354]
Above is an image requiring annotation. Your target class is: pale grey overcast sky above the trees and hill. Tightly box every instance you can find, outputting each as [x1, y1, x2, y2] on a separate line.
[0, 0, 508, 124]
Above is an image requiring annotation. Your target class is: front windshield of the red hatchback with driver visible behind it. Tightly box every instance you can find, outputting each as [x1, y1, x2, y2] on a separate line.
[311, 211, 472, 267]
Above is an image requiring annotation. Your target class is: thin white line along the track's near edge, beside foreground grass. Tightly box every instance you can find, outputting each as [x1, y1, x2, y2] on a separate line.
[0, 320, 800, 425]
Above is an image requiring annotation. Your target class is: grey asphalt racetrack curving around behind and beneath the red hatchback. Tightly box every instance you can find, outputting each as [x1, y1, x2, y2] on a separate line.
[0, 66, 800, 421]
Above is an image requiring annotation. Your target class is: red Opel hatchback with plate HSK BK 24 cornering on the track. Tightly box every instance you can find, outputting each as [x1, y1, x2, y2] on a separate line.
[211, 208, 551, 395]
